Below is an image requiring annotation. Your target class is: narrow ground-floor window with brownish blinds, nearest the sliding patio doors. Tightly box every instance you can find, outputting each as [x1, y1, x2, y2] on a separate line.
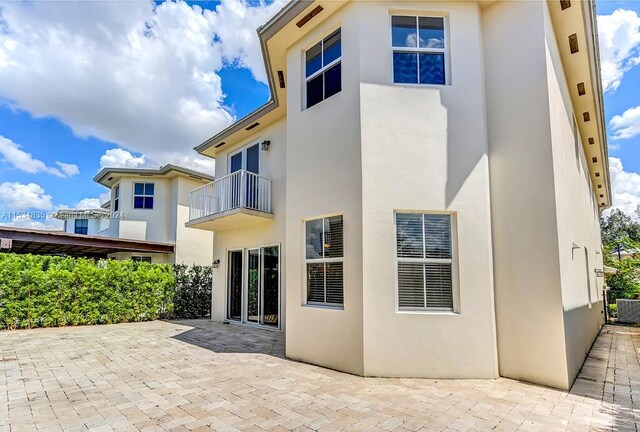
[305, 216, 344, 306]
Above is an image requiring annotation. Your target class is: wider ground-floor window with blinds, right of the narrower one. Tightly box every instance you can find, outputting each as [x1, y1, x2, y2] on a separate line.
[396, 213, 453, 311]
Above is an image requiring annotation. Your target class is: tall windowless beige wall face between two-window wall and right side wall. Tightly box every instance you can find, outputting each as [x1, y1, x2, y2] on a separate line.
[482, 2, 567, 387]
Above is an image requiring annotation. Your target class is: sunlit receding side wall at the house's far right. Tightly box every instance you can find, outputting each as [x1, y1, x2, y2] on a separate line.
[544, 8, 604, 385]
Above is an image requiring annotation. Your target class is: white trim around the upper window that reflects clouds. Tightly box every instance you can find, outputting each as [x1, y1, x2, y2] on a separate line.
[389, 11, 451, 88]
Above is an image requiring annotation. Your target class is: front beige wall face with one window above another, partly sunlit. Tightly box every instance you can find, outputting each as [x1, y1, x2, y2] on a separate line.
[358, 2, 498, 378]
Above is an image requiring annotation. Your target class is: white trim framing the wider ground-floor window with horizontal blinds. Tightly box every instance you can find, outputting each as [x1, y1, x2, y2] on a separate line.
[393, 210, 462, 316]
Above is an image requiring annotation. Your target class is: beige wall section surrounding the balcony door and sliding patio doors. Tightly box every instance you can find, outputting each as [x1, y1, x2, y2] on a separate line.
[209, 120, 287, 328]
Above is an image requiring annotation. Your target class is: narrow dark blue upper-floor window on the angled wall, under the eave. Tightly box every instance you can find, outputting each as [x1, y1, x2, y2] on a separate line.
[305, 29, 342, 108]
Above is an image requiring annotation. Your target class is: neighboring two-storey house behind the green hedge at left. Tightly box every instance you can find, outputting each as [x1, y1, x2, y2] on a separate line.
[55, 165, 213, 265]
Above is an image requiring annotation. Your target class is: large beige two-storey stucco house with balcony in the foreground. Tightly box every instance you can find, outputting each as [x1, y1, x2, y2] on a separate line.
[184, 1, 611, 389]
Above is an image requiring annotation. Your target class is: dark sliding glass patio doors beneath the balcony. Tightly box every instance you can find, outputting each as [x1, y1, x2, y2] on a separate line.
[227, 246, 280, 328]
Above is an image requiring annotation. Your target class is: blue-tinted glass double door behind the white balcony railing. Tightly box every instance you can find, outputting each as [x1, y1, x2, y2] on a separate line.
[229, 144, 260, 208]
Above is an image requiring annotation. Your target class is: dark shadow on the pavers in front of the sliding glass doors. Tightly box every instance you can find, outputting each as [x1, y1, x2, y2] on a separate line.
[168, 319, 284, 358]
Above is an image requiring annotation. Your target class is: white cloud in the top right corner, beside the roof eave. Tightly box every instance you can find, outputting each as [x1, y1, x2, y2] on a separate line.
[598, 9, 640, 92]
